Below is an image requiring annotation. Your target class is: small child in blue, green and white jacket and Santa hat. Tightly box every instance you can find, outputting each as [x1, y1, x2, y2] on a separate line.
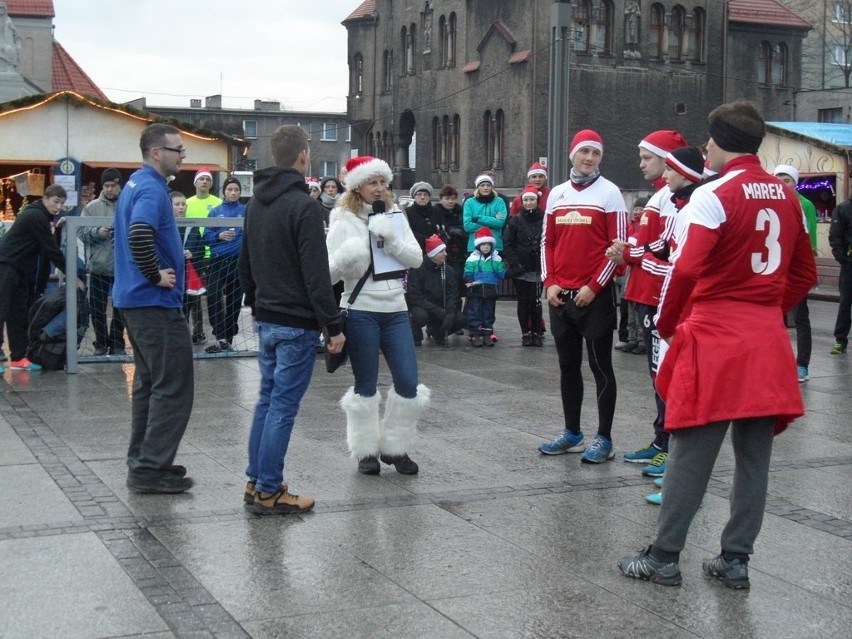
[464, 226, 506, 346]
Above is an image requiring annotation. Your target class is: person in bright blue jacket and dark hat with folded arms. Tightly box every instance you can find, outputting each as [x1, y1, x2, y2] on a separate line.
[204, 177, 246, 353]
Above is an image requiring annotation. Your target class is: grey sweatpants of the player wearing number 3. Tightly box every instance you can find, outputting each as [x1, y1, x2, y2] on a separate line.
[654, 417, 775, 555]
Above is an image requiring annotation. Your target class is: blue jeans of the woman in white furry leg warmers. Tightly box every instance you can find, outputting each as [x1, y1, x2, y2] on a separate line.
[346, 310, 417, 399]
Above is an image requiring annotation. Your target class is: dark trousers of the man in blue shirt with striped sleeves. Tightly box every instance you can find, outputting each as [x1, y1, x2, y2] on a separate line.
[121, 307, 195, 482]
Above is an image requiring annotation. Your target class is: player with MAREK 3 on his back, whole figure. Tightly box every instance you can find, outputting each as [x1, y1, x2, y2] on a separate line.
[618, 101, 816, 588]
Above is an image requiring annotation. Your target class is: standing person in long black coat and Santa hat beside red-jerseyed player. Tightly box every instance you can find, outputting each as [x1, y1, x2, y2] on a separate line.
[503, 185, 544, 346]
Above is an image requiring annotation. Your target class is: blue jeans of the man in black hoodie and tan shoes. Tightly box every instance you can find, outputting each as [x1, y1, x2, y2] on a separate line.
[246, 322, 320, 493]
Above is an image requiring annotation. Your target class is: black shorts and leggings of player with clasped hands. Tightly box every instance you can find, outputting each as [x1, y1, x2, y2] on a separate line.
[550, 289, 618, 437]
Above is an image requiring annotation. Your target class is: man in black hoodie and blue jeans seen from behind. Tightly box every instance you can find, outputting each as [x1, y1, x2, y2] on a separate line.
[239, 125, 346, 514]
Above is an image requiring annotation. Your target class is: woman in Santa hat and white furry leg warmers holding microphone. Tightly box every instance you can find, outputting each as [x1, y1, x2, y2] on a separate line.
[326, 156, 429, 475]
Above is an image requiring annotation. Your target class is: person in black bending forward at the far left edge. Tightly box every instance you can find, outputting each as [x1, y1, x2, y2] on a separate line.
[0, 184, 83, 371]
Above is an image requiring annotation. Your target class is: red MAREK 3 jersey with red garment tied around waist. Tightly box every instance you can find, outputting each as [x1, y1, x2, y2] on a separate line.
[656, 155, 816, 432]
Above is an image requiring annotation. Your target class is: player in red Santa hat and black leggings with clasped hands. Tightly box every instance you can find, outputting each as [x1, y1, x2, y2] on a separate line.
[538, 129, 627, 464]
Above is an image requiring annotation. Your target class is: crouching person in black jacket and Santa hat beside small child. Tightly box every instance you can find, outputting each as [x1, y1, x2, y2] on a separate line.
[408, 235, 467, 346]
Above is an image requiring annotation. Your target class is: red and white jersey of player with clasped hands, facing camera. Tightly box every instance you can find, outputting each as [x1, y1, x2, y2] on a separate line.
[541, 177, 627, 295]
